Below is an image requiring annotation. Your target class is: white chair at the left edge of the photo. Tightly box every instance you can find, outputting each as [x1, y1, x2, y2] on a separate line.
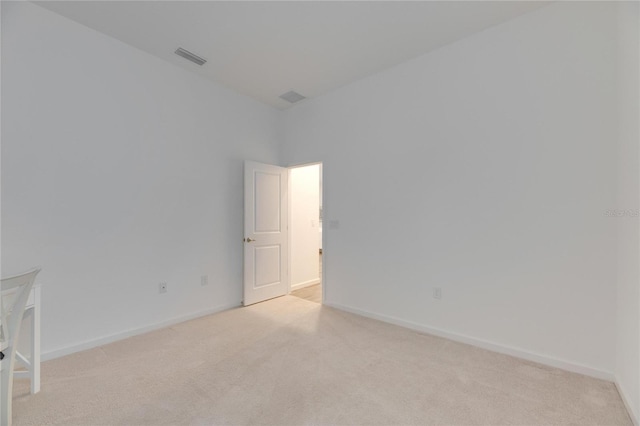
[0, 268, 40, 426]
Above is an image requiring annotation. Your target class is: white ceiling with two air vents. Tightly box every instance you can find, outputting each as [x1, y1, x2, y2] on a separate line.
[36, 1, 547, 109]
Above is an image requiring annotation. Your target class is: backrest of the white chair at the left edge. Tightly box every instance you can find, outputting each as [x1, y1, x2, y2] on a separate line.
[0, 268, 40, 344]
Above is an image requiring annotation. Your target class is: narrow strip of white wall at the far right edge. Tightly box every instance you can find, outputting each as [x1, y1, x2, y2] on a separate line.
[613, 2, 640, 424]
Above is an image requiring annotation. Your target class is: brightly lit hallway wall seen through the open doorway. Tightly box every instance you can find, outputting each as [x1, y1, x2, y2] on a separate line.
[289, 164, 320, 289]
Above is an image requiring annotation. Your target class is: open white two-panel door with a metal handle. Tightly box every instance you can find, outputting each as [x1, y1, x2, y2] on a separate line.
[243, 161, 289, 306]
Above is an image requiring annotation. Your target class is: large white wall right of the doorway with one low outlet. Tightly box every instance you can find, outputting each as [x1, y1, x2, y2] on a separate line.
[281, 2, 616, 378]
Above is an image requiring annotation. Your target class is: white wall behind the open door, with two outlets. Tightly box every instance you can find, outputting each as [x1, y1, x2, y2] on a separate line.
[2, 2, 278, 355]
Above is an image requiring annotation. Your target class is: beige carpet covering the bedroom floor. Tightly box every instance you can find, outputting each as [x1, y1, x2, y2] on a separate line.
[14, 296, 631, 425]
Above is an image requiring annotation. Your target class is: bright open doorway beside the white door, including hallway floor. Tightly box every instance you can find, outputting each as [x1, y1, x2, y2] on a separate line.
[289, 163, 323, 303]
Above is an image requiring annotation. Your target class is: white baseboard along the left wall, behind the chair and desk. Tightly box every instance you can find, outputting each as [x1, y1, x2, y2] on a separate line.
[41, 304, 240, 361]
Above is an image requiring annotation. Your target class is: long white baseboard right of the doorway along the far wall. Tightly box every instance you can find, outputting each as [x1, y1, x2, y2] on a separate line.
[324, 302, 615, 382]
